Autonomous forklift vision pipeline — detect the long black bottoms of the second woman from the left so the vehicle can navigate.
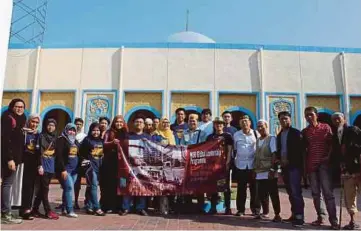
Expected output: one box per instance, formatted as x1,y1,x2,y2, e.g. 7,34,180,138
21,153,38,211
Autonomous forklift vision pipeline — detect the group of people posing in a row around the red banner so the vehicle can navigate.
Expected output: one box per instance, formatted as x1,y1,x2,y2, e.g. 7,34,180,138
1,99,361,230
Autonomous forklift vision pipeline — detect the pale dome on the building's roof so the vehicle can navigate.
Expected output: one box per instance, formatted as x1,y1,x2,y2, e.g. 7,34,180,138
168,31,216,43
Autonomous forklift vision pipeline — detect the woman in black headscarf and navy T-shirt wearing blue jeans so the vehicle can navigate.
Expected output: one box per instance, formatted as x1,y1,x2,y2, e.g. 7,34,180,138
80,122,105,216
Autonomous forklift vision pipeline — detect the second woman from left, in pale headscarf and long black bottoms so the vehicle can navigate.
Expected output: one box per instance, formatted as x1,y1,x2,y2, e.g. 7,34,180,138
20,114,40,220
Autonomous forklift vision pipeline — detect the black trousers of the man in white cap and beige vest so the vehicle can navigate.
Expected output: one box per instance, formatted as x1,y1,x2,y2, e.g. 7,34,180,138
255,178,281,215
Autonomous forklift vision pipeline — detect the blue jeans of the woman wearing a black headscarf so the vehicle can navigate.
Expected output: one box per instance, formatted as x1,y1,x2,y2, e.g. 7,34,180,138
85,168,100,210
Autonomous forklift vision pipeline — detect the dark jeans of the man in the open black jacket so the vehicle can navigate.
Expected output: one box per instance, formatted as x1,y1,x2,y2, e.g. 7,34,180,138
282,167,305,220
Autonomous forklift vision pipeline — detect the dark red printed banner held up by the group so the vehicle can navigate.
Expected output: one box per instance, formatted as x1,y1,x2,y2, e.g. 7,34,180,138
118,140,228,196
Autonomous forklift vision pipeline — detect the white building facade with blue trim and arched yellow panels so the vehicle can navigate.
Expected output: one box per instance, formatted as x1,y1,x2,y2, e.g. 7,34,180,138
2,43,361,133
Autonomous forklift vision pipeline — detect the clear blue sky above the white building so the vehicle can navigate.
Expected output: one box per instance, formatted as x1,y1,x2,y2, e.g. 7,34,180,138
8,0,361,48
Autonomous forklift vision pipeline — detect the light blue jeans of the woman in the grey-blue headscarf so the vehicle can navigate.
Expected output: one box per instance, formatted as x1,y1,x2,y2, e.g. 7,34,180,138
60,172,78,213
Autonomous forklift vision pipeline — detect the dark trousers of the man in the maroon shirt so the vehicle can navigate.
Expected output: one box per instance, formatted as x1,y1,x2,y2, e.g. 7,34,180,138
309,164,337,223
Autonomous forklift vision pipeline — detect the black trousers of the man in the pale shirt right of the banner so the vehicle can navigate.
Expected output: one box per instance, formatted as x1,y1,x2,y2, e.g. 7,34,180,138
234,168,257,213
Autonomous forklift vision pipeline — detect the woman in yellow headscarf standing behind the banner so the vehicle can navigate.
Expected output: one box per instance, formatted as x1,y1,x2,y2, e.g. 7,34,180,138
156,117,176,215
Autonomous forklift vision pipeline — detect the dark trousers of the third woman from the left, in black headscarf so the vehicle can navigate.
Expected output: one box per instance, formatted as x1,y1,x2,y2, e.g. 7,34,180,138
33,172,54,213
